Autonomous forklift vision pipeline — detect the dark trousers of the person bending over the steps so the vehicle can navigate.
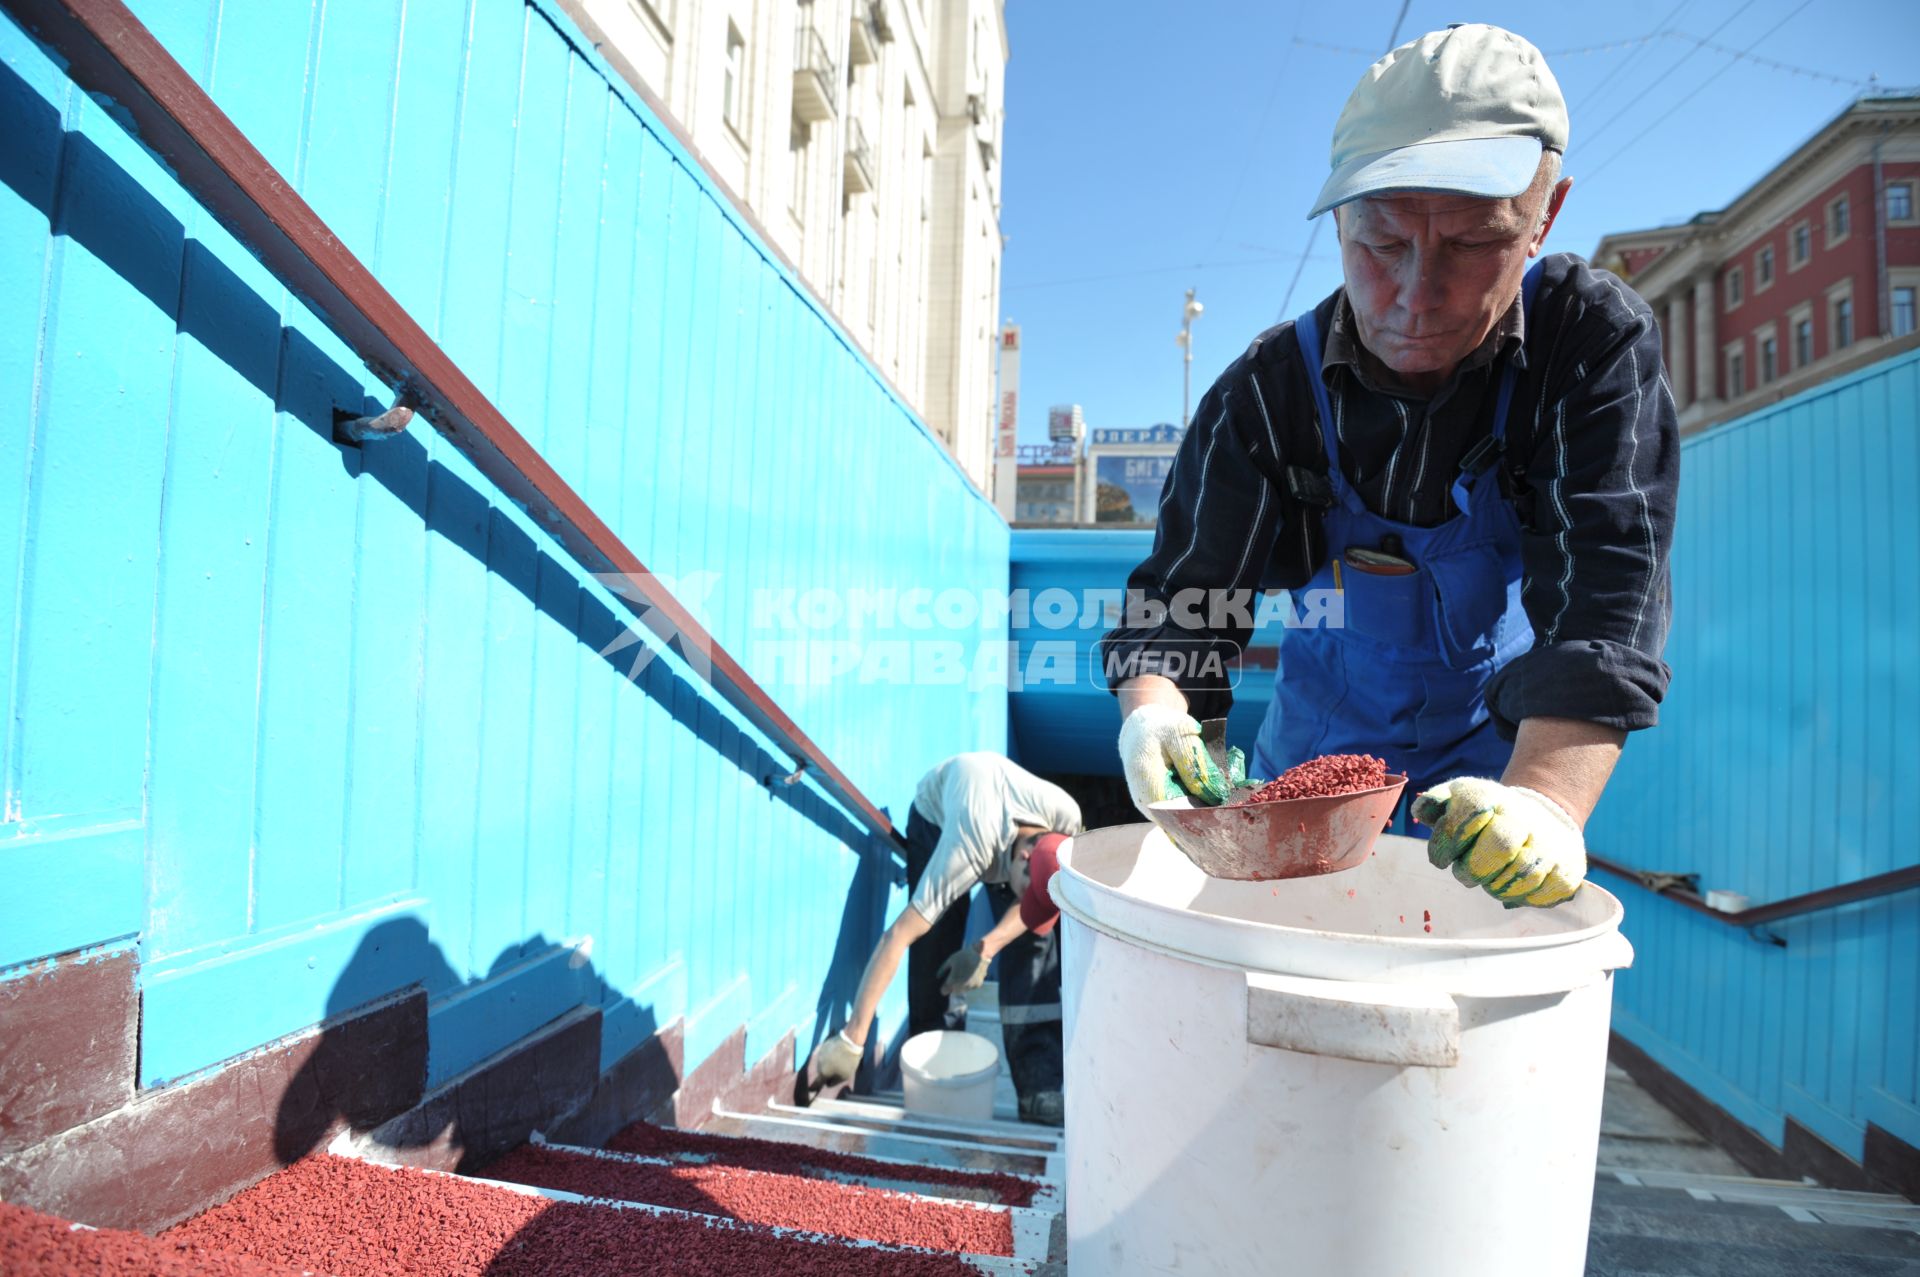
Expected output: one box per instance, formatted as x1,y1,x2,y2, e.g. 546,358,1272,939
906,808,1064,1095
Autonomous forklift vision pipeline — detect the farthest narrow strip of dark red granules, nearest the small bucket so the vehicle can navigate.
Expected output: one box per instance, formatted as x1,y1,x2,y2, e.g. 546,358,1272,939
607,1121,1062,1212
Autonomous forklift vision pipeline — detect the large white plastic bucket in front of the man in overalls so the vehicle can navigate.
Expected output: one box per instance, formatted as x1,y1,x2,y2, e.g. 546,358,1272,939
1050,824,1632,1277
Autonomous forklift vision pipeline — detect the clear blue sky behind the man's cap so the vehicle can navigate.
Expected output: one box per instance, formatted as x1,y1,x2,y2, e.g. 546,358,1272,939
1000,0,1920,442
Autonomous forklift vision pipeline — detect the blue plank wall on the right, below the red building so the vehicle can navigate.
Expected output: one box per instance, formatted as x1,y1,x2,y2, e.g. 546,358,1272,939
1590,345,1920,1160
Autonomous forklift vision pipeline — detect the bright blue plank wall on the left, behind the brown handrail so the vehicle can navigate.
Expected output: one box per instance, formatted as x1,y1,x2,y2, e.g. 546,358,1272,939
0,0,1008,1083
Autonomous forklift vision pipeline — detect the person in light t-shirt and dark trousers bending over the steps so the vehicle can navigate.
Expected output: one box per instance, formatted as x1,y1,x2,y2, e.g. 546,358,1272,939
808,753,1081,1125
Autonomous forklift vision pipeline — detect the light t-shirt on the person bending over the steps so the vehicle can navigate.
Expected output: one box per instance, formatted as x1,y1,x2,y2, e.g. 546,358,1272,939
912,753,1081,922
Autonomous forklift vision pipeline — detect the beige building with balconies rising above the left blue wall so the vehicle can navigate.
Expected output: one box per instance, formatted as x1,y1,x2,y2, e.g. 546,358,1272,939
563,0,1008,492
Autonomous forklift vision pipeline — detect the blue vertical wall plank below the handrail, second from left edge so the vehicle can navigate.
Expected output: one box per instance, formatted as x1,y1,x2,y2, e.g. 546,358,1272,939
15,98,186,820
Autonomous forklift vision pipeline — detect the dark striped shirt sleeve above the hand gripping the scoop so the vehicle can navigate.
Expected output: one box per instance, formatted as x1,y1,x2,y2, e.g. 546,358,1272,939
1098,351,1283,718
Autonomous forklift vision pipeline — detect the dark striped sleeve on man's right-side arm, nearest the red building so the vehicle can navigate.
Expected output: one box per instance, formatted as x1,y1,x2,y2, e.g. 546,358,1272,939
1486,271,1680,739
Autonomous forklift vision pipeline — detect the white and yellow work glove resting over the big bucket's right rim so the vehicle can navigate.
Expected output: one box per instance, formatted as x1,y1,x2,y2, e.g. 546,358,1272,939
1413,776,1586,908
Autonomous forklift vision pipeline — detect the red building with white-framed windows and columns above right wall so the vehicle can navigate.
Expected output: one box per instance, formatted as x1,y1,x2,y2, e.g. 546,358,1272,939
1594,92,1920,430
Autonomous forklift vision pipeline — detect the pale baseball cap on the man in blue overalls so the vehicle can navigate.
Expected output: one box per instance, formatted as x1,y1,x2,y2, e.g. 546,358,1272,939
1308,23,1567,217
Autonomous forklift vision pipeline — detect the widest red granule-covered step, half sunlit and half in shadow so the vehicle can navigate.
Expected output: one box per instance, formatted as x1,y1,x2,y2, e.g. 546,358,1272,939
163,1154,973,1277
